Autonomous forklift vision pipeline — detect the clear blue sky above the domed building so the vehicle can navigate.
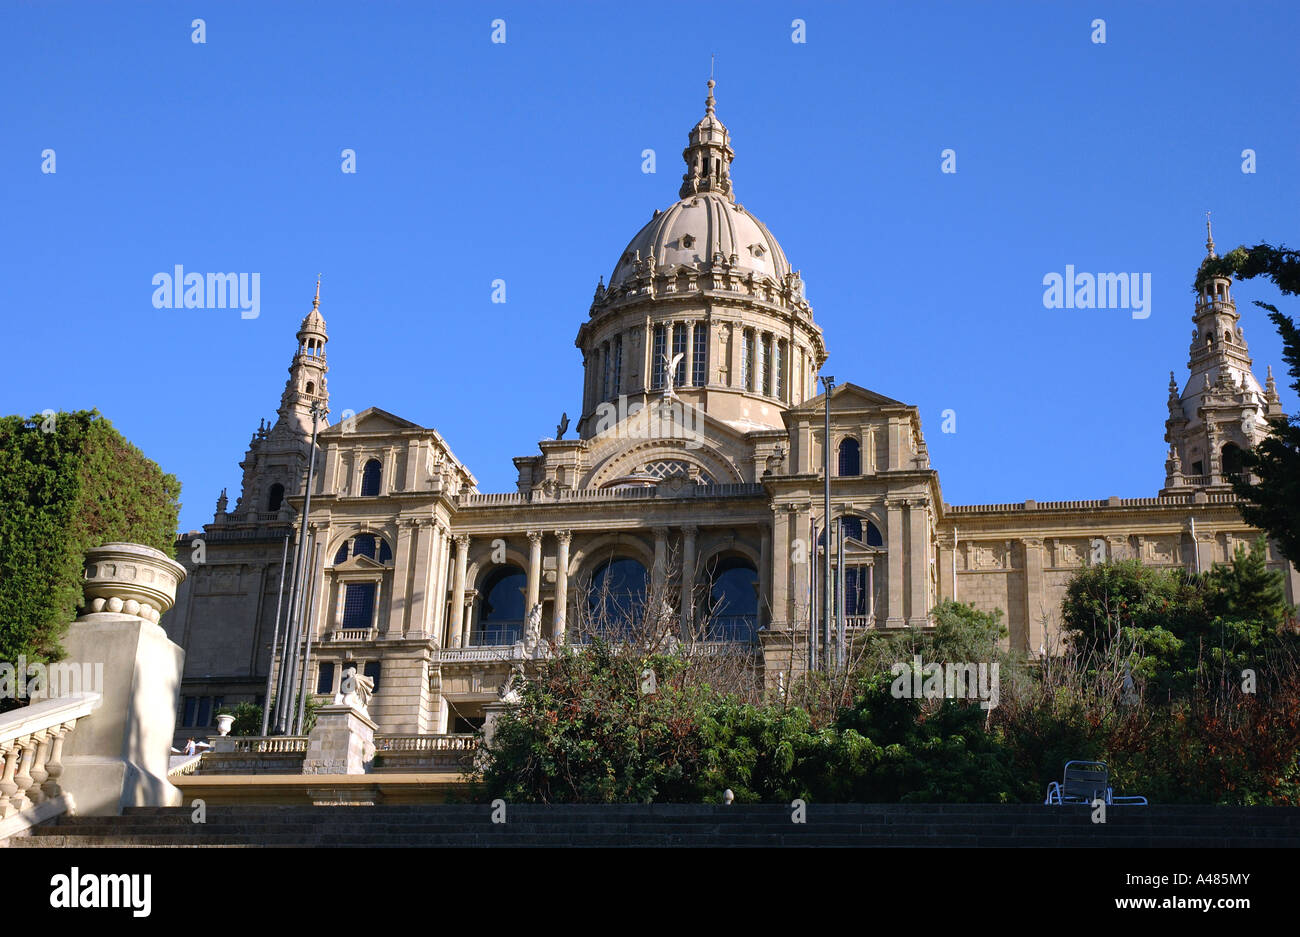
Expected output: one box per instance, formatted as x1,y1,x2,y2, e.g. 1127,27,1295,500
0,0,1300,530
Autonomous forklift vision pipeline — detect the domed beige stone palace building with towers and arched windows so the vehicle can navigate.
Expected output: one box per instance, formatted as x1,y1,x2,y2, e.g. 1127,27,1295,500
164,81,1300,737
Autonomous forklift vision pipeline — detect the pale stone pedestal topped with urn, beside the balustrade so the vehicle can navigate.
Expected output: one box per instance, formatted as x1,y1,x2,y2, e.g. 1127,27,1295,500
58,543,186,816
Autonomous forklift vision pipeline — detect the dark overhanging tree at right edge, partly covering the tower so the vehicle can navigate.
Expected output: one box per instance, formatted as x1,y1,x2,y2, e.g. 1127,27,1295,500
1195,244,1300,564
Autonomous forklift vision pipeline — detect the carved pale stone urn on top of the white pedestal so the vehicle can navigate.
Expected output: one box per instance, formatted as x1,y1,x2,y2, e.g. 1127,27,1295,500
82,543,186,625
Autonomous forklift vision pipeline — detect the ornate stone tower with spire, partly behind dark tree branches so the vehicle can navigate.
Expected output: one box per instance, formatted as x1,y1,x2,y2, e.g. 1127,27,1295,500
1161,216,1282,494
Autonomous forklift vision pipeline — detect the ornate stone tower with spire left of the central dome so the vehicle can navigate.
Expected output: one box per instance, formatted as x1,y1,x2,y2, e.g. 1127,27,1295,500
216,279,329,525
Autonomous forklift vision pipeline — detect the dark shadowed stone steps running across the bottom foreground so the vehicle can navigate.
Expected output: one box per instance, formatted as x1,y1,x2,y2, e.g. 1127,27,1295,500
8,804,1300,849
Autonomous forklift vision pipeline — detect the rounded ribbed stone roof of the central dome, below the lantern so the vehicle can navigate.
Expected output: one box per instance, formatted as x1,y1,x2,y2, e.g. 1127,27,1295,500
610,192,790,289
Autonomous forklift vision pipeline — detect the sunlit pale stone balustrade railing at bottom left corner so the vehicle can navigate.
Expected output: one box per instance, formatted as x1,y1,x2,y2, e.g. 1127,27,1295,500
0,693,101,840
